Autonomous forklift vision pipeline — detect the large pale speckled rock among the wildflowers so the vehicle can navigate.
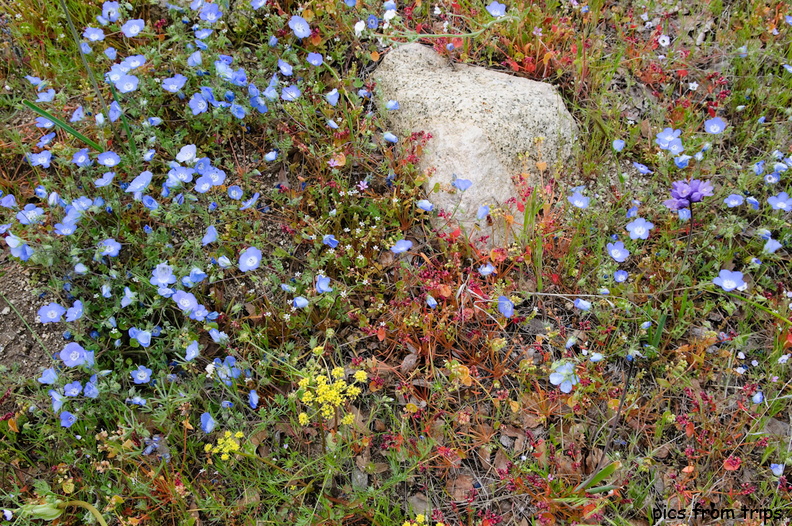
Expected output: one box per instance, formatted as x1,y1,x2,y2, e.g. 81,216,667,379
373,44,577,246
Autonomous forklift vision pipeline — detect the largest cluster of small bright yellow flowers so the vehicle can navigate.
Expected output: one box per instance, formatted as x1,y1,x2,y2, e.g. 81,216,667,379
297,367,368,426
